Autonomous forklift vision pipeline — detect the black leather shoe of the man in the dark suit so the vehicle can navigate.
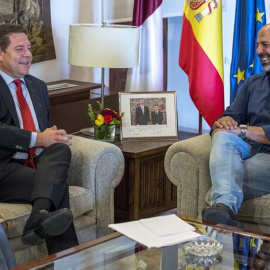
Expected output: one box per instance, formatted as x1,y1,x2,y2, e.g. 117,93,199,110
22,208,73,246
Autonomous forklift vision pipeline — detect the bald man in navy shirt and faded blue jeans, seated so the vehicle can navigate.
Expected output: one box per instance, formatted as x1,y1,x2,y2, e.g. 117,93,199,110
202,24,270,226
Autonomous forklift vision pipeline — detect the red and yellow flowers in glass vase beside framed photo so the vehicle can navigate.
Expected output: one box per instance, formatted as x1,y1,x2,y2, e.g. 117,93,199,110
88,101,124,141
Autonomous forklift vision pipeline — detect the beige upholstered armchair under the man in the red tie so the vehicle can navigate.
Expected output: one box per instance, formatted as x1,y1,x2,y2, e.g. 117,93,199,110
0,136,124,265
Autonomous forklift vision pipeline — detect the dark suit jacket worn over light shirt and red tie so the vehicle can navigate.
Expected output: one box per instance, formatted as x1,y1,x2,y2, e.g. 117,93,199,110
0,75,51,175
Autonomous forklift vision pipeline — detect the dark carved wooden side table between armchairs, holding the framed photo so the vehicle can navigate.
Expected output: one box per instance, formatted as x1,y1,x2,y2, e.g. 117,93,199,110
114,140,177,222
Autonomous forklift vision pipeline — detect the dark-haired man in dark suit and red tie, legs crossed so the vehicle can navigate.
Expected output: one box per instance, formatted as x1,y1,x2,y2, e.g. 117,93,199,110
0,24,78,254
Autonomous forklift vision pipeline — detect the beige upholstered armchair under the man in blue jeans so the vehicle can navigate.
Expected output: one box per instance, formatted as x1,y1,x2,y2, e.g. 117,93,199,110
165,134,270,233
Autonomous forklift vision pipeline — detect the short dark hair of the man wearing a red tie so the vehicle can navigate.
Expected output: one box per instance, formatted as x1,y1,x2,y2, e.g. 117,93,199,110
0,24,28,52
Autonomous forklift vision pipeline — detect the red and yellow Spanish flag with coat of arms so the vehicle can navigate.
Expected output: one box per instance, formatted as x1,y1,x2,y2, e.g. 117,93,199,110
179,0,224,126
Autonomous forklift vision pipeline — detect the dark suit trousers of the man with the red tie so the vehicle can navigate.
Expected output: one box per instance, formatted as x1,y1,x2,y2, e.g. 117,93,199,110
0,143,78,254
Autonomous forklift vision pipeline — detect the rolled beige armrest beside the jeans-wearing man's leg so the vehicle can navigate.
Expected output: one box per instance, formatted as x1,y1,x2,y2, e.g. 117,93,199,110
164,134,211,218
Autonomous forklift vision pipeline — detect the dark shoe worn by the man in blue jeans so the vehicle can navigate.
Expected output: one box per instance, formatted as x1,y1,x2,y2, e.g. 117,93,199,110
202,203,244,228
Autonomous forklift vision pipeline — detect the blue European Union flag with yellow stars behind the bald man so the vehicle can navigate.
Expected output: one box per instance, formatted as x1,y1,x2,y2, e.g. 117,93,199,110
230,0,266,103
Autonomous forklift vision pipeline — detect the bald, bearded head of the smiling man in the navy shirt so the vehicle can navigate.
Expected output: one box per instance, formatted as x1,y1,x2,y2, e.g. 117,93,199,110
256,24,270,71
